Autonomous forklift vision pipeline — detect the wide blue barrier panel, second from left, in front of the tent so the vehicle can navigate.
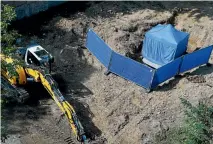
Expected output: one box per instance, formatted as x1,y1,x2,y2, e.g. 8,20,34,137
109,52,154,89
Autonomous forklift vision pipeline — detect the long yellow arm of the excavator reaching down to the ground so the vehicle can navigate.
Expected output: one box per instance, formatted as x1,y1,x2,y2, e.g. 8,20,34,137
25,68,87,144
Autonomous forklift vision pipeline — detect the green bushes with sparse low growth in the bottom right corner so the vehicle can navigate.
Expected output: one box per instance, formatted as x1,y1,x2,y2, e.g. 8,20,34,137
156,98,213,144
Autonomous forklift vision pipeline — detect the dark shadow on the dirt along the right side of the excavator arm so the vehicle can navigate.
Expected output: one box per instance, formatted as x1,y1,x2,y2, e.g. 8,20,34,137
53,75,102,139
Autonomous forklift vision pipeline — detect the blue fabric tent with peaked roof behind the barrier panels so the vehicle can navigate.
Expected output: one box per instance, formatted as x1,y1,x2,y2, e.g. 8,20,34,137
142,24,189,66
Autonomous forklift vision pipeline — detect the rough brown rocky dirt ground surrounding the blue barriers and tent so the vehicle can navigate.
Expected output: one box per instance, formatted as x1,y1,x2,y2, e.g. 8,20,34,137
2,2,213,144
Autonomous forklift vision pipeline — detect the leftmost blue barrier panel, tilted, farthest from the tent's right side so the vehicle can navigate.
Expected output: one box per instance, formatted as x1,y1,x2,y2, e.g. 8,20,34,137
86,29,112,68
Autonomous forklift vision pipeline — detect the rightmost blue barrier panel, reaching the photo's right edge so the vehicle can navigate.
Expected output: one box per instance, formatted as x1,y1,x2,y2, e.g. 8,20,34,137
179,46,213,73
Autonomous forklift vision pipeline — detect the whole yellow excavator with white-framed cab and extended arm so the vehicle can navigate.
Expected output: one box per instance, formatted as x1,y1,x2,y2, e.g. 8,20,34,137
0,44,87,144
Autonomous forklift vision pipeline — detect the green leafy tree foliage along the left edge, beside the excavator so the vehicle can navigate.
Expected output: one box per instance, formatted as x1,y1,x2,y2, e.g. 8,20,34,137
0,5,22,141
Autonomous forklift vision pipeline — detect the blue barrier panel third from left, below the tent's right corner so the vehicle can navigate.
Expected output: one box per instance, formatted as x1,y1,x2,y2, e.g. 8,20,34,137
152,57,182,88
